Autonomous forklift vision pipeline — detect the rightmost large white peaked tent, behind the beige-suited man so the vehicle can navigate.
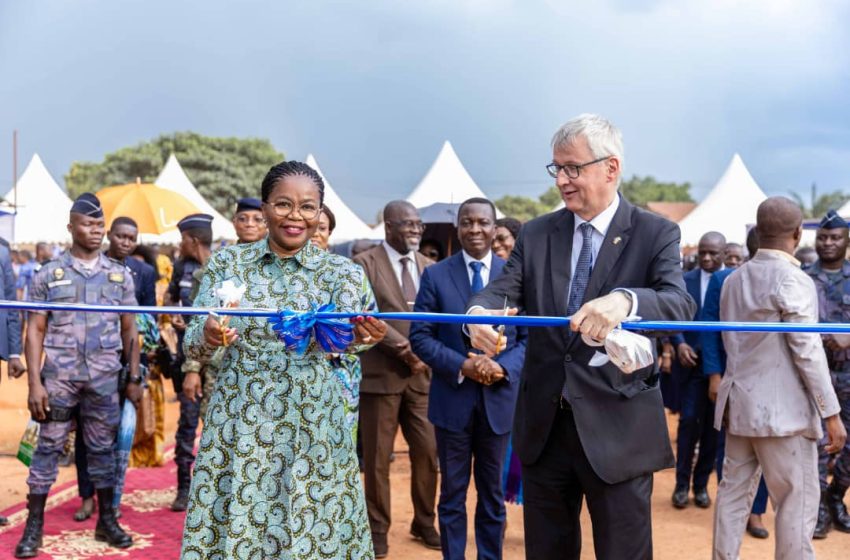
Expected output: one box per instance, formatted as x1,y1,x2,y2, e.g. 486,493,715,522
679,154,767,245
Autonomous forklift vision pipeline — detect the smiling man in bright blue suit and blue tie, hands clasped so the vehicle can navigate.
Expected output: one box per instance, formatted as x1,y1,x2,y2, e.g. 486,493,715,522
410,198,527,560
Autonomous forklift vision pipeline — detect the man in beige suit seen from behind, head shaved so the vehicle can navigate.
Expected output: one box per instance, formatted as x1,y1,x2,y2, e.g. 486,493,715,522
714,197,847,560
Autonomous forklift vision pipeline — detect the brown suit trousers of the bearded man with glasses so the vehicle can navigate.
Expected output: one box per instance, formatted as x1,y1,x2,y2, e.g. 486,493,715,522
360,387,437,533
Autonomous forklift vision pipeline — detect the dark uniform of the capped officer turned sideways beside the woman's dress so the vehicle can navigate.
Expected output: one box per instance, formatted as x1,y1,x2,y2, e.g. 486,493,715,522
168,259,202,469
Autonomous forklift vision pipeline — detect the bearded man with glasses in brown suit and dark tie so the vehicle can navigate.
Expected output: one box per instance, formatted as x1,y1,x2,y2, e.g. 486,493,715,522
354,200,440,558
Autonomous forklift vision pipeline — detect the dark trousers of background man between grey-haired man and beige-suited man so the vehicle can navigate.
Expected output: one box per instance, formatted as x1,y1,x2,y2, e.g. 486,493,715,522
676,370,717,490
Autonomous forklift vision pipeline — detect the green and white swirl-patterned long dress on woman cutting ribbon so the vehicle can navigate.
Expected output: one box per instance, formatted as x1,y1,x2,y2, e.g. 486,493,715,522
182,240,373,560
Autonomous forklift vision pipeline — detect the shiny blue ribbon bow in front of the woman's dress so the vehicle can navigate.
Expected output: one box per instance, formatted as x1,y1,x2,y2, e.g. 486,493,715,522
269,303,354,354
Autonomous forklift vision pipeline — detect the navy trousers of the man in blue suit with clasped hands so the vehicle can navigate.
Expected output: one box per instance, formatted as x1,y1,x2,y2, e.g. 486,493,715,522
435,390,511,560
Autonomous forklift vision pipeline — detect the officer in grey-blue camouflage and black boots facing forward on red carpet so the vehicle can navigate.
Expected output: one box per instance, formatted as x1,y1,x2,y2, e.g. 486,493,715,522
15,193,141,558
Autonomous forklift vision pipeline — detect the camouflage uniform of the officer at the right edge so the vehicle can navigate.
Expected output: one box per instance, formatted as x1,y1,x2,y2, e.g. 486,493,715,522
806,261,850,491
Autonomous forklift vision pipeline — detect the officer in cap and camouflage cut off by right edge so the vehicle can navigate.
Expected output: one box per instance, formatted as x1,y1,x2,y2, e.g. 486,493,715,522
806,210,850,539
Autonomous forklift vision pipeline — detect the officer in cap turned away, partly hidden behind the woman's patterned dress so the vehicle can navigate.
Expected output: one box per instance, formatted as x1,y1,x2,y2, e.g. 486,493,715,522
168,214,213,511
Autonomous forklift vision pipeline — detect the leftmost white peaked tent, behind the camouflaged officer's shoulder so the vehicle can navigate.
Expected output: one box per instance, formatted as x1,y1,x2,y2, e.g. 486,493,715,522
3,154,73,243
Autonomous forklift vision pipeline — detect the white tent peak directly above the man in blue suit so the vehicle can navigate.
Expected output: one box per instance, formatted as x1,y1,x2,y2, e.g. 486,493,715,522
407,140,502,218
